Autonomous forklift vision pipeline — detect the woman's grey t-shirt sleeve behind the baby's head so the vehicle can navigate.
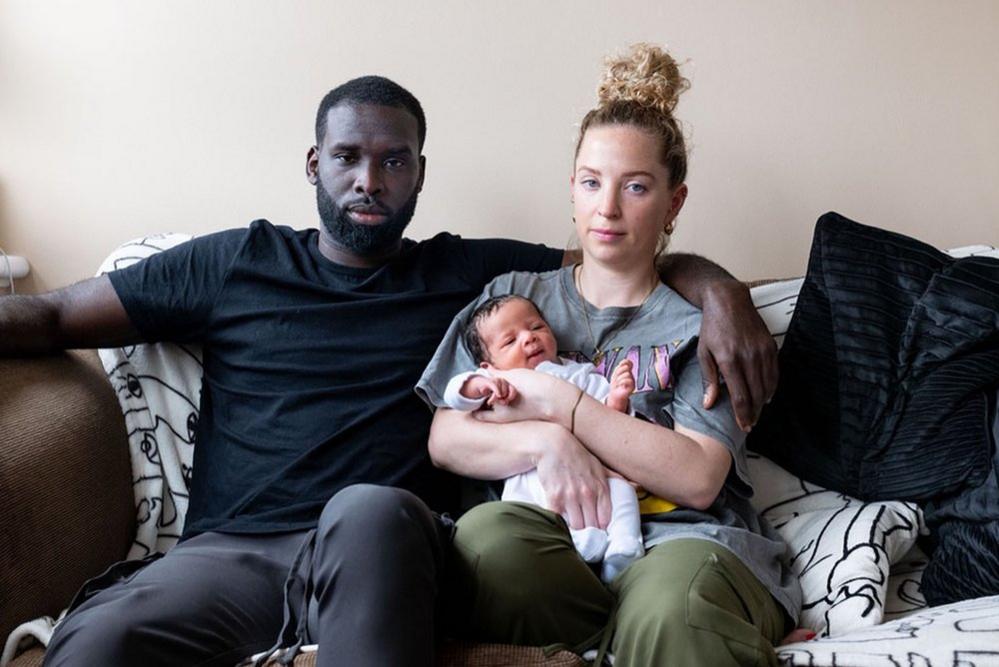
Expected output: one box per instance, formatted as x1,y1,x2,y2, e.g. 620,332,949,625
416,273,518,409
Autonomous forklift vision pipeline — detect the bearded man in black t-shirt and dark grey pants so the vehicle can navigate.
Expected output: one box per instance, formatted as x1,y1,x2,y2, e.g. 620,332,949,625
0,77,775,666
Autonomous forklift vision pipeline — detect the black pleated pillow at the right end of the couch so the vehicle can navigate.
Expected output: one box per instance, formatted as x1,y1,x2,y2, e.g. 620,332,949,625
748,213,999,602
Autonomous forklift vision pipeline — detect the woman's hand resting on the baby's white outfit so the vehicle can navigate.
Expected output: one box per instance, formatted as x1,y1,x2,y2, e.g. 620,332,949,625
537,424,611,530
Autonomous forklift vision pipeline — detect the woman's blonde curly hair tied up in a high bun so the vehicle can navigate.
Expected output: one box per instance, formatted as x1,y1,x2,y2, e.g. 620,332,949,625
576,43,690,187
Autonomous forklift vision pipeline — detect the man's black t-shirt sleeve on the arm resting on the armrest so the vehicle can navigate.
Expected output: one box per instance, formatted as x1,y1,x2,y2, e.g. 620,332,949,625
108,230,246,343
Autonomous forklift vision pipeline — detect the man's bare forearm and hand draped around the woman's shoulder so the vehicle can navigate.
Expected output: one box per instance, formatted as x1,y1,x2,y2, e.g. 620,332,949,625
658,253,778,431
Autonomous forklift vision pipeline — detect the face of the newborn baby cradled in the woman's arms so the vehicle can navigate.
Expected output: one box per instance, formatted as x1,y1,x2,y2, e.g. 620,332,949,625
479,299,558,370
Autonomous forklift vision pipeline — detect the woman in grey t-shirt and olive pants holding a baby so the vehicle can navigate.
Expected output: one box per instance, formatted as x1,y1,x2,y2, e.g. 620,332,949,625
420,45,800,666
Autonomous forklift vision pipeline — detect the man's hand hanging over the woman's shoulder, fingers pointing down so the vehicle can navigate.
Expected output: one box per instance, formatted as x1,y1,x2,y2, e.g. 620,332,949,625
697,280,778,433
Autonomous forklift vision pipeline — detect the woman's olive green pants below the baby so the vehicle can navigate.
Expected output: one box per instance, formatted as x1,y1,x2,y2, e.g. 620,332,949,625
446,502,785,667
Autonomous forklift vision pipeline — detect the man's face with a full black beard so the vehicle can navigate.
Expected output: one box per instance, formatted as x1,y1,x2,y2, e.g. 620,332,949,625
306,103,423,256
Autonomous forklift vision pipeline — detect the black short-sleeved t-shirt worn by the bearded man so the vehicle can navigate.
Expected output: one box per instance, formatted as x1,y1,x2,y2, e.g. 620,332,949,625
109,220,562,537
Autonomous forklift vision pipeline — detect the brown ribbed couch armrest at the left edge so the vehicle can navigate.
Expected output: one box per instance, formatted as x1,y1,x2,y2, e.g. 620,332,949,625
0,351,135,645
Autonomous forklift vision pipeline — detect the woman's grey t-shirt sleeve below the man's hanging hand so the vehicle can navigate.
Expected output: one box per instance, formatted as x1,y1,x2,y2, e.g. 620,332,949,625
665,355,752,497
